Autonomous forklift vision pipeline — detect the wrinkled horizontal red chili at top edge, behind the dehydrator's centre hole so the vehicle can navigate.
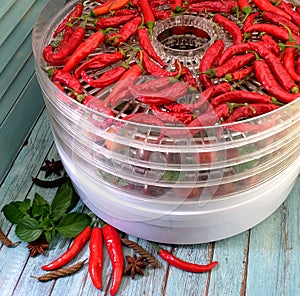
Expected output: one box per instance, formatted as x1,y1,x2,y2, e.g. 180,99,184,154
189,1,238,13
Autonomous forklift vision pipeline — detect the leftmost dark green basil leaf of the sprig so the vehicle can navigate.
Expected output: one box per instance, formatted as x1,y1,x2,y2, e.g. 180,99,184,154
2,199,30,224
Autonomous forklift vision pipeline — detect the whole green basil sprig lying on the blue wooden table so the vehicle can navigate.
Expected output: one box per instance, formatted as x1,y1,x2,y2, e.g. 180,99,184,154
2,180,91,243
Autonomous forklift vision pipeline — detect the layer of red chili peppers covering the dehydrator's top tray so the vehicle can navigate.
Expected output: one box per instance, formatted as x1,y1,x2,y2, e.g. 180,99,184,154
43,0,300,134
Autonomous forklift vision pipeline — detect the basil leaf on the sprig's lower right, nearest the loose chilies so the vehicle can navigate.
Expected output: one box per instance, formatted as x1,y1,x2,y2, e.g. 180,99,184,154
56,212,91,238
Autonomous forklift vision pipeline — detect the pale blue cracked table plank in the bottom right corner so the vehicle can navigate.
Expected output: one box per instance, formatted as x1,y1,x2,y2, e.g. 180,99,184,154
246,176,300,296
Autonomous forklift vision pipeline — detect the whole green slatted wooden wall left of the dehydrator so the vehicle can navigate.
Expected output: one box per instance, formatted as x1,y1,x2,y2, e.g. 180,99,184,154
0,0,50,184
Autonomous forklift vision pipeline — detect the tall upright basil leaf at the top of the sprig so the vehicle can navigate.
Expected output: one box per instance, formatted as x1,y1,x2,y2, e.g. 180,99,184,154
51,181,73,221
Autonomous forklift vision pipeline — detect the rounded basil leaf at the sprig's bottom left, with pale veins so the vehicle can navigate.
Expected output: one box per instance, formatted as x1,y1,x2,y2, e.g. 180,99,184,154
16,218,43,243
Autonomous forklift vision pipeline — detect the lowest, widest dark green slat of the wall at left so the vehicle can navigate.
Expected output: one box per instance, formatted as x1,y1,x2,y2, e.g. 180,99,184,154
0,76,44,180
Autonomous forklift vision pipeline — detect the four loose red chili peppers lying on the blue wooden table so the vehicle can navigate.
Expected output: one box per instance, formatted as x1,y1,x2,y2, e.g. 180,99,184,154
42,221,218,295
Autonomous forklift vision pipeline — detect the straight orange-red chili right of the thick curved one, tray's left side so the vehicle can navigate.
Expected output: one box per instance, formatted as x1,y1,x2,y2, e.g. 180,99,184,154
62,31,105,72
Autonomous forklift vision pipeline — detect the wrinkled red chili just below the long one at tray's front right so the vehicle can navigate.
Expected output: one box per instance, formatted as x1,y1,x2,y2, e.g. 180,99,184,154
226,103,279,123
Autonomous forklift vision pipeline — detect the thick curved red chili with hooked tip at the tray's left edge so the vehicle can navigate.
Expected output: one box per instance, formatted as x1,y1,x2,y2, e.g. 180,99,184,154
43,27,85,66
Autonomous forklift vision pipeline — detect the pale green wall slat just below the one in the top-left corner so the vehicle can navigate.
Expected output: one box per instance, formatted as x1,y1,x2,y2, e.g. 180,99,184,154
0,0,36,46
